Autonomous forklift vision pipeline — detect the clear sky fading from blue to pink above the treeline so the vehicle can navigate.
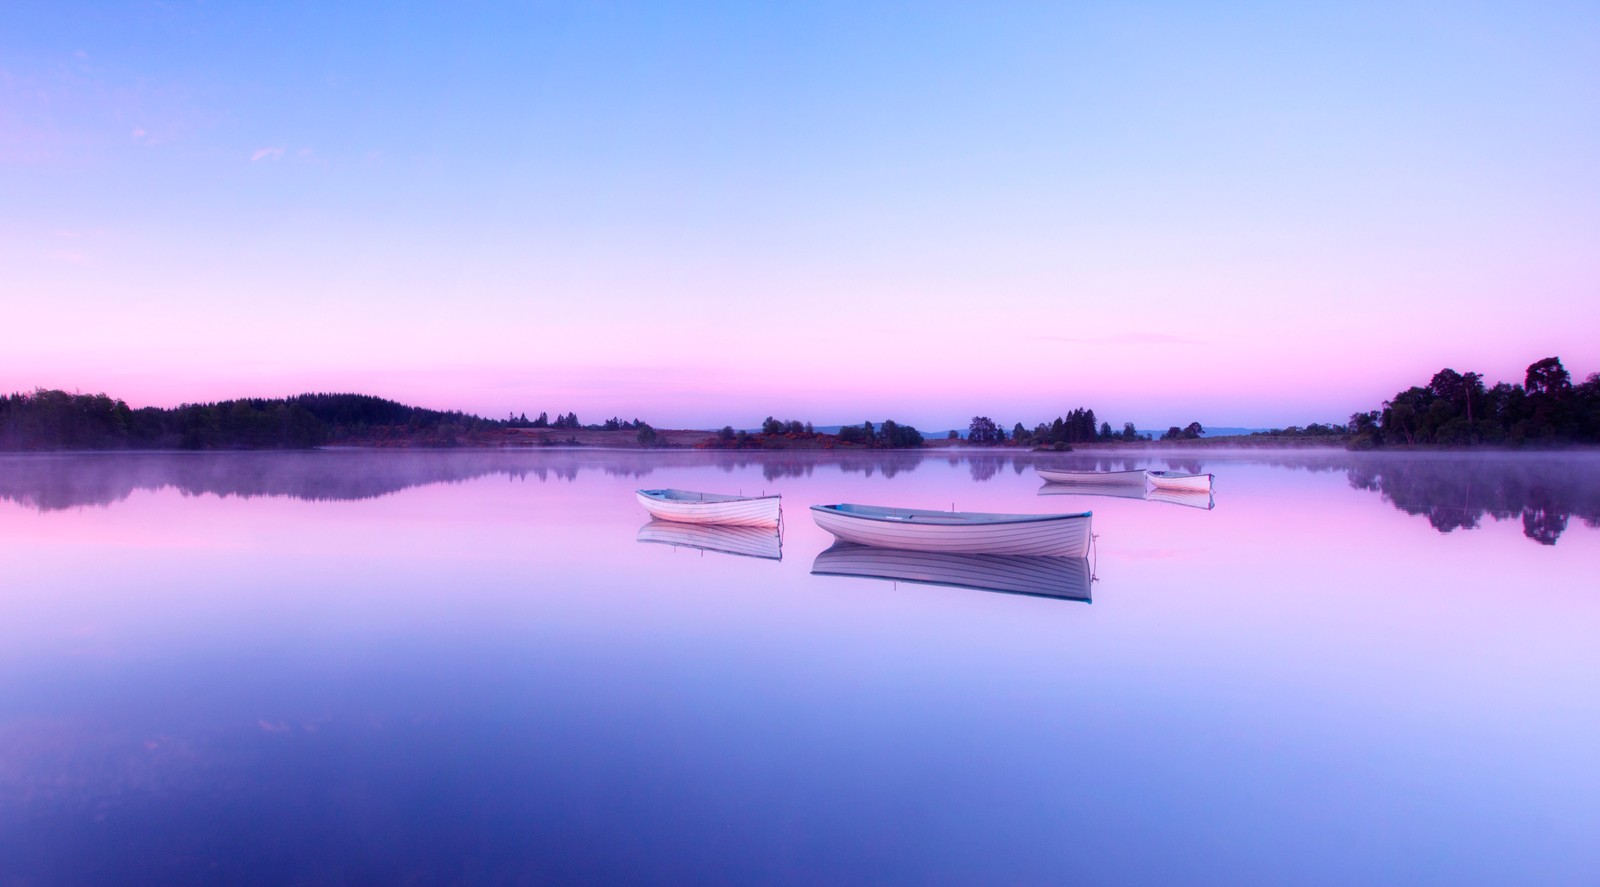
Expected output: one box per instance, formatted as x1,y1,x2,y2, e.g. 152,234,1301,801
0,2,1600,427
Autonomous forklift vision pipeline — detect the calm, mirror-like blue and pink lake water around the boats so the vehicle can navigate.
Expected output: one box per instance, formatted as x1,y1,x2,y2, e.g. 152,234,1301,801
0,450,1600,885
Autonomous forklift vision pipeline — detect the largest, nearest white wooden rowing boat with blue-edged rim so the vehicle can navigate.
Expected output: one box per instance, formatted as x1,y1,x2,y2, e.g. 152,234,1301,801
811,504,1091,557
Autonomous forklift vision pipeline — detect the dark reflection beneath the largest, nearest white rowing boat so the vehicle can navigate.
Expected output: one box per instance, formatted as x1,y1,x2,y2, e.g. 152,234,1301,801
811,543,1093,604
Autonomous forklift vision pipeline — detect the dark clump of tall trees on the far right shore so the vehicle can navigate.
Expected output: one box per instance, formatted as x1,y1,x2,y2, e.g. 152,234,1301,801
1350,357,1600,450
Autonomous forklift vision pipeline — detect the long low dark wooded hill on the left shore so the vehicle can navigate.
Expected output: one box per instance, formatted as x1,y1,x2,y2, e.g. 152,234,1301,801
0,389,506,450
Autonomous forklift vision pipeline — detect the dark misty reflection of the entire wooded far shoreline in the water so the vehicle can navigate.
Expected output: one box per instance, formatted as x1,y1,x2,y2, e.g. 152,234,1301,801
0,448,1600,544
